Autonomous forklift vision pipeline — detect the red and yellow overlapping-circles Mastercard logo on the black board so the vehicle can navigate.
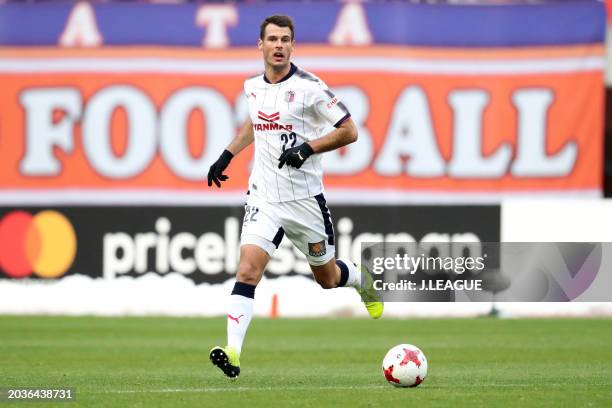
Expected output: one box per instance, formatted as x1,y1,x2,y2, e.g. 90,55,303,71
0,210,77,278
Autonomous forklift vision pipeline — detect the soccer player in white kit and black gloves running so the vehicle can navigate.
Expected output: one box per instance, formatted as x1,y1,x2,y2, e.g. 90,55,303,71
208,15,383,378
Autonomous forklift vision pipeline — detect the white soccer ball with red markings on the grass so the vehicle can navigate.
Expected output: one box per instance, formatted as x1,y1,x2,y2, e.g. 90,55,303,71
382,344,427,387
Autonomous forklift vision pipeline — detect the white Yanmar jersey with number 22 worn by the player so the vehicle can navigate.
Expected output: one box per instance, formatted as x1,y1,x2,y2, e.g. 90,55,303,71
244,64,350,202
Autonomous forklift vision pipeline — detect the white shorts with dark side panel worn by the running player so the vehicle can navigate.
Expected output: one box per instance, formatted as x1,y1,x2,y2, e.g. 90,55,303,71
240,193,336,266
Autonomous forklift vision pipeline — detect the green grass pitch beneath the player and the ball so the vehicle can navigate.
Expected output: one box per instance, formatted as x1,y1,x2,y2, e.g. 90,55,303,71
0,316,612,408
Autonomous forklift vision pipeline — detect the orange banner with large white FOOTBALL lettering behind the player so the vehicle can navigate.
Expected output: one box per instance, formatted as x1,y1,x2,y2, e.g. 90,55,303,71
0,46,604,204
